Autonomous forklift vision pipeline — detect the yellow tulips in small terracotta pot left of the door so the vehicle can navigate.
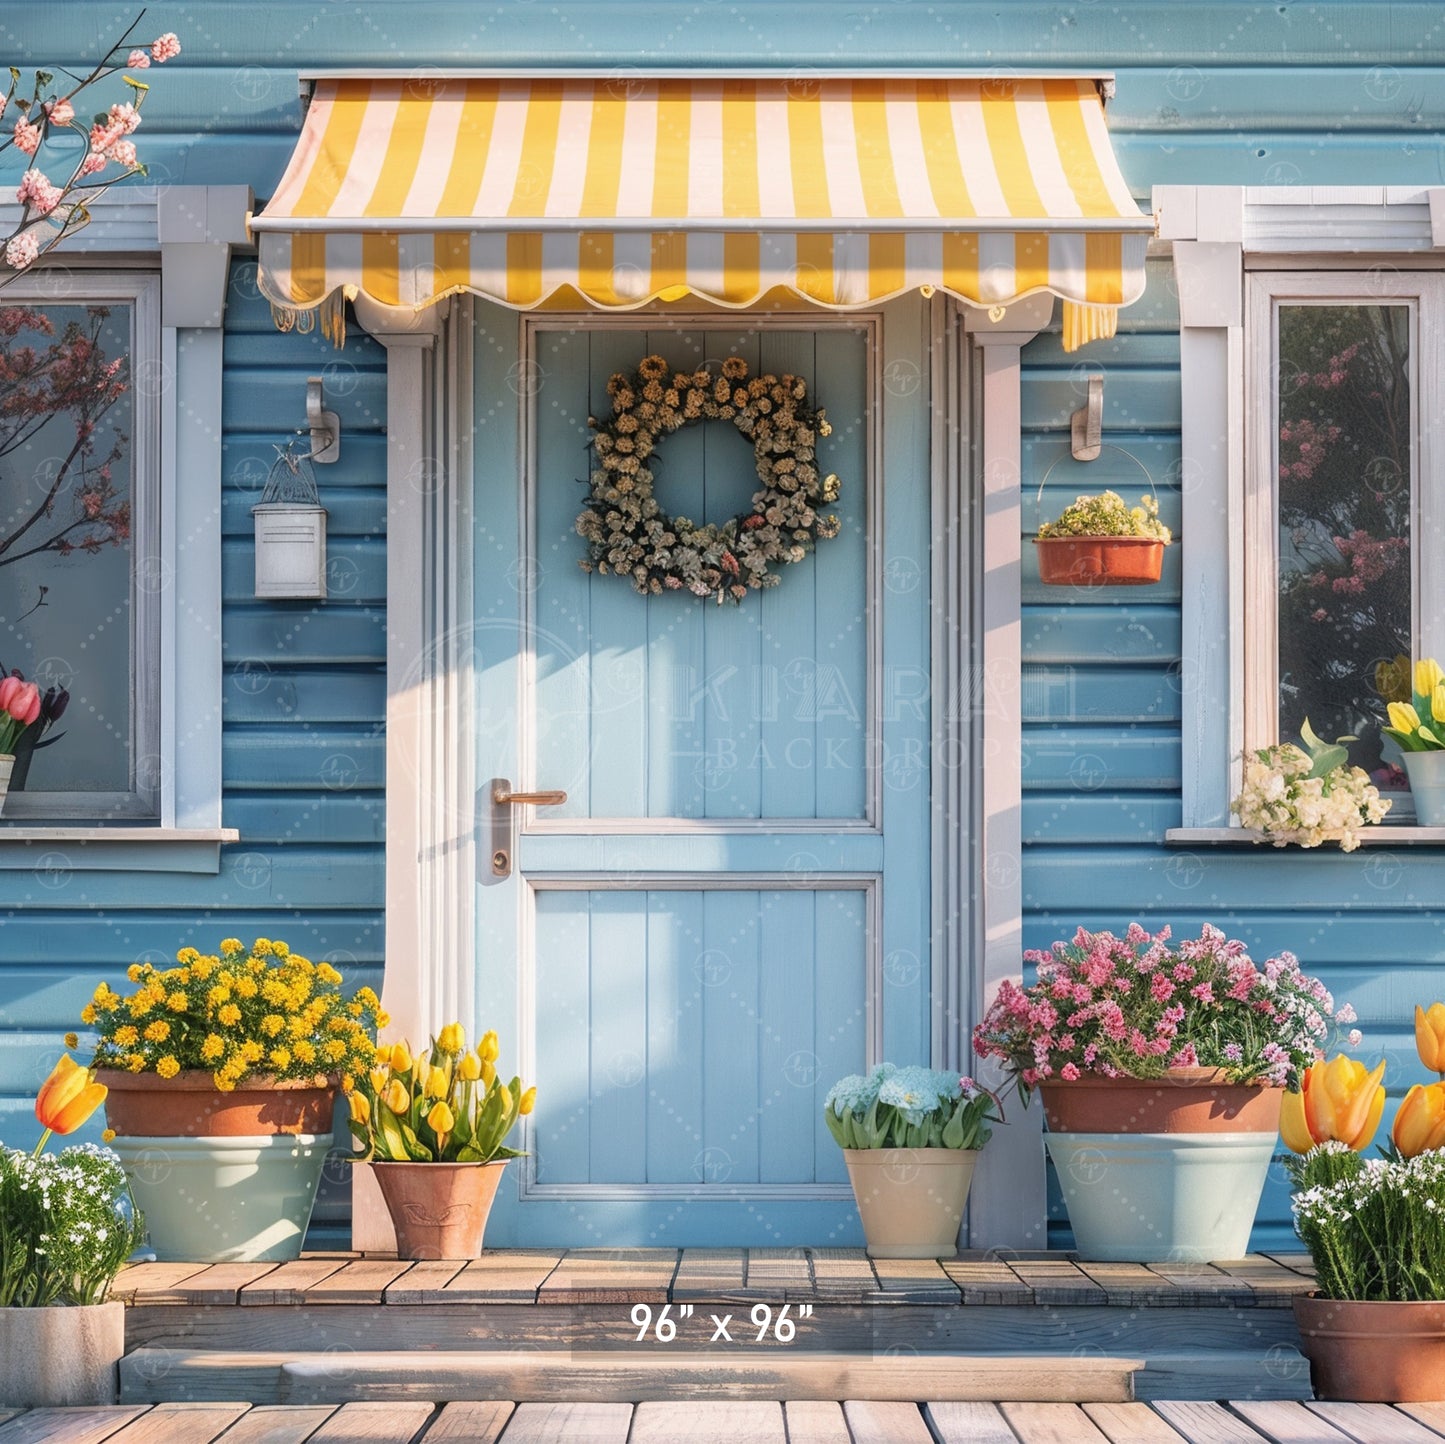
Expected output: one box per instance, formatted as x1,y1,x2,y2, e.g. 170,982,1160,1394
350,1023,536,1259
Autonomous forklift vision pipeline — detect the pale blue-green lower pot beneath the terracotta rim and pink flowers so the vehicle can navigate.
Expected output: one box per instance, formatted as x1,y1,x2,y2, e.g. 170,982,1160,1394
1043,1133,1277,1263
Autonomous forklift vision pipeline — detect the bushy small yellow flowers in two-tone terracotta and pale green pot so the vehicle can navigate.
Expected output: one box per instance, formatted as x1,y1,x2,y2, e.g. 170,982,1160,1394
81,938,386,1263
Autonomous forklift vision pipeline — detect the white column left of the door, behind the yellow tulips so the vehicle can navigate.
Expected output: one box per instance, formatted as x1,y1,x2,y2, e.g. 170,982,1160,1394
351,298,475,1253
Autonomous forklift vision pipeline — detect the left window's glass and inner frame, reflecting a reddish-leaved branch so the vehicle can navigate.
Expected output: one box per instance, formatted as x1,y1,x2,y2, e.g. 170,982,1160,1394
0,270,162,822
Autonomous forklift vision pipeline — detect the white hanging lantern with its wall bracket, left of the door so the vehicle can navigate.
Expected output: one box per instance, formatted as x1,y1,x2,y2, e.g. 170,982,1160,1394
251,376,341,598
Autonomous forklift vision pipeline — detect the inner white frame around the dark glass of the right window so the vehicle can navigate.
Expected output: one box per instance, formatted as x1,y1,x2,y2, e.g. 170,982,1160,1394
1231,267,1445,827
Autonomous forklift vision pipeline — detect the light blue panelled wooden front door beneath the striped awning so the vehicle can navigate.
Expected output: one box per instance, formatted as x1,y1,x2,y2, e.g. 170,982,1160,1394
474,296,931,1246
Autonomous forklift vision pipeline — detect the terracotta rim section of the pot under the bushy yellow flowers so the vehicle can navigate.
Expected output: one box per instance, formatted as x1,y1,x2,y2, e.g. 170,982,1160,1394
95,1068,337,1138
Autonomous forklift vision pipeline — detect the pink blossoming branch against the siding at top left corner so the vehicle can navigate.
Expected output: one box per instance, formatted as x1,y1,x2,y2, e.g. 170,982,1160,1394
0,12,181,278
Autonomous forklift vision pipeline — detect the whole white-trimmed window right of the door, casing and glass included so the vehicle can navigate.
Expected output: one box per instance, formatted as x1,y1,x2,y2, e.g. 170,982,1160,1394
1153,185,1445,846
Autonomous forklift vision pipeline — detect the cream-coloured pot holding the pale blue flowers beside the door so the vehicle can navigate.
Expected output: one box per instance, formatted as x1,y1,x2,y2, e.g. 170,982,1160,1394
842,1148,978,1259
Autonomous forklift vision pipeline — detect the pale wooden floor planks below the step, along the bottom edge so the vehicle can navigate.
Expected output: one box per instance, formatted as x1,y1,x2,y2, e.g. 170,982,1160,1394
0,1401,1445,1444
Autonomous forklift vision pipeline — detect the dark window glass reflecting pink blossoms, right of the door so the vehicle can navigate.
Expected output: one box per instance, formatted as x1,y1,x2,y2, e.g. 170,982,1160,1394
1277,302,1418,785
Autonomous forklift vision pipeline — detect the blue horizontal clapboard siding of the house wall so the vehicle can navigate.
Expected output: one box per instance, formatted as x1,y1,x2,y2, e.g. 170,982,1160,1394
0,0,1445,1243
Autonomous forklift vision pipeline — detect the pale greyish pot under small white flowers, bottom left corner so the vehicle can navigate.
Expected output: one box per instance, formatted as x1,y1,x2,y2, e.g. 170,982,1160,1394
0,1302,126,1409
